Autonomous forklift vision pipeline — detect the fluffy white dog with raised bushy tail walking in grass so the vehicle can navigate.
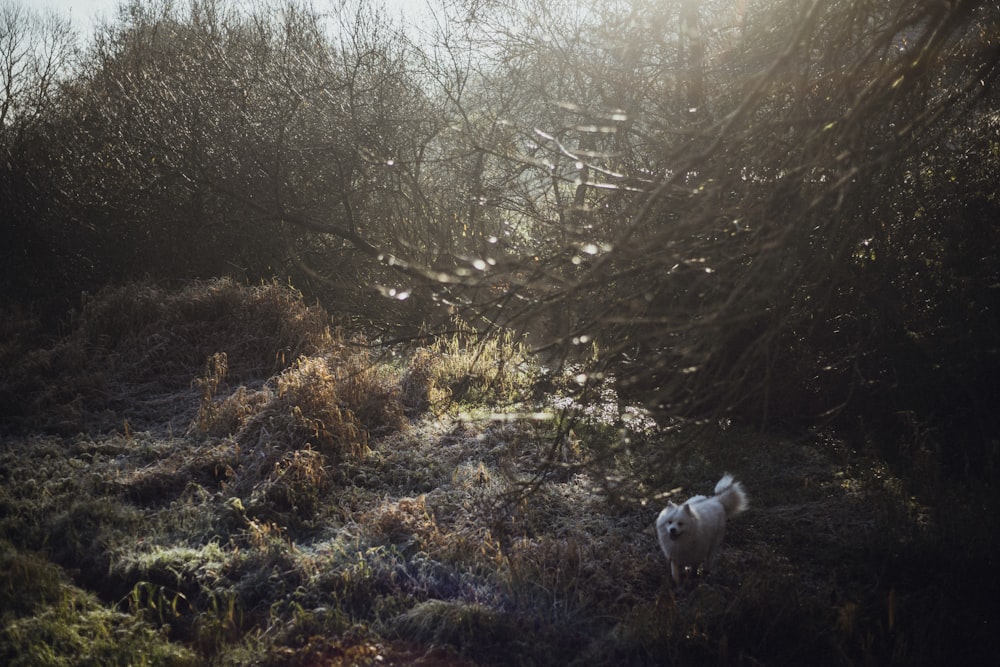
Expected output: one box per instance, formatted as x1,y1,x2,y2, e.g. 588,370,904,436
656,473,748,584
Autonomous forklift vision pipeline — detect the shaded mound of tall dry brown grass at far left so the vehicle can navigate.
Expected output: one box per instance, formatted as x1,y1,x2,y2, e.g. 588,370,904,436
0,279,332,433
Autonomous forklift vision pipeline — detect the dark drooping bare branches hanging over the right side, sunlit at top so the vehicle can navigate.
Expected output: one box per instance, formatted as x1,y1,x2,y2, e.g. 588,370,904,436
532,2,998,444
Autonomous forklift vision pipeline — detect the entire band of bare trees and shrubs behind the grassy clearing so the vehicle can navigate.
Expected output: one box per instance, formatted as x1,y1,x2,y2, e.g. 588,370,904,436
0,0,1000,460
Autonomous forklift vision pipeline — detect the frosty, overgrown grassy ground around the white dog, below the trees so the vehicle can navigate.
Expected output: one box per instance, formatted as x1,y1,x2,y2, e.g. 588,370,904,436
0,281,998,665
